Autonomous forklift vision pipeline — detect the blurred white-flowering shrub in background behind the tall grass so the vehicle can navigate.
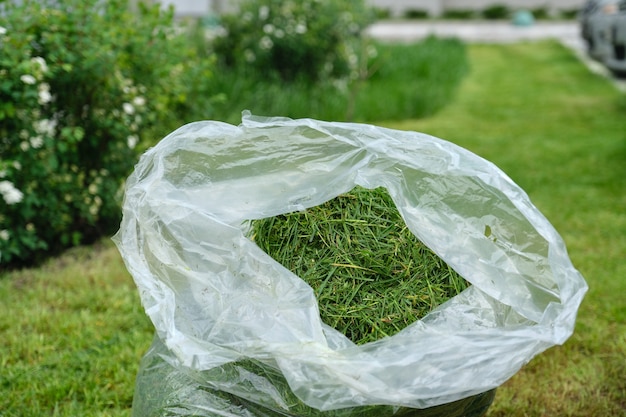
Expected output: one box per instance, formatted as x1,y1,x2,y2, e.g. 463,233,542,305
214,0,374,82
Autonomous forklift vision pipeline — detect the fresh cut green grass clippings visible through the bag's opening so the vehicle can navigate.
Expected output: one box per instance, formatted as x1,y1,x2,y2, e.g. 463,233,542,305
251,187,468,344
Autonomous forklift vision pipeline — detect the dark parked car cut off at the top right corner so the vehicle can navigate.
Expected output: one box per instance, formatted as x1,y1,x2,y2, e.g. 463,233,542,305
579,0,626,74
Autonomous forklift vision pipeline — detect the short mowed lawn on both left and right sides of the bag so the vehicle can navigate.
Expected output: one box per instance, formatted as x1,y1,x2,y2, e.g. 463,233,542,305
0,42,626,417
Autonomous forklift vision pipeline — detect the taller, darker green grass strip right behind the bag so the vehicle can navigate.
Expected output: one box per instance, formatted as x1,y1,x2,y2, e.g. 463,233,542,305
205,37,467,124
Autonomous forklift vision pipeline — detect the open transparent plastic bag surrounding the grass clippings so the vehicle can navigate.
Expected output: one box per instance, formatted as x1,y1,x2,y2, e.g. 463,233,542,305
114,113,587,416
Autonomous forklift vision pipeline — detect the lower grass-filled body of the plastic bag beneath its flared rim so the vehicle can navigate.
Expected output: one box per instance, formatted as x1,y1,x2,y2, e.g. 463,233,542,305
133,337,496,417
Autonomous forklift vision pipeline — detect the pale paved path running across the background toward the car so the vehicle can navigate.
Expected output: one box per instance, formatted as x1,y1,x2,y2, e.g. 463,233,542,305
367,20,626,91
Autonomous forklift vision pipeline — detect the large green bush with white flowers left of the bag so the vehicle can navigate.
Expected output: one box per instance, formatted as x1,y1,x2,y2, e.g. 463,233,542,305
0,0,217,266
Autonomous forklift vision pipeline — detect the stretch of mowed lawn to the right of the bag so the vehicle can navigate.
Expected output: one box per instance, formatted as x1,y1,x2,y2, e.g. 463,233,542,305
386,42,626,417
